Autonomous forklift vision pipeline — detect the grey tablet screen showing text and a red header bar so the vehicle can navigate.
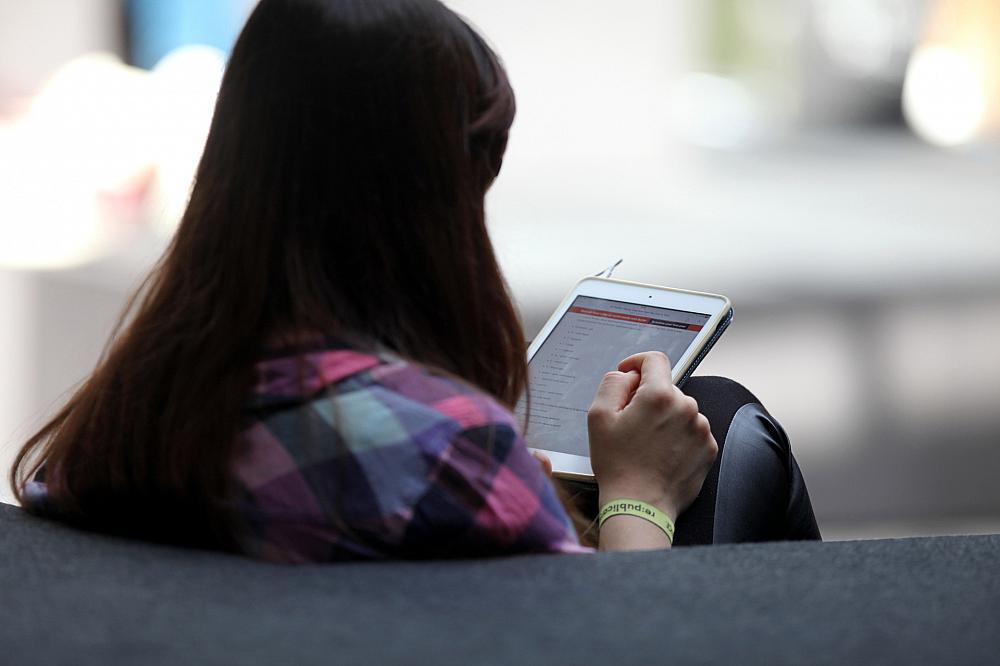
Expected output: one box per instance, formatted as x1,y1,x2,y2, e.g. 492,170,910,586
517,296,710,456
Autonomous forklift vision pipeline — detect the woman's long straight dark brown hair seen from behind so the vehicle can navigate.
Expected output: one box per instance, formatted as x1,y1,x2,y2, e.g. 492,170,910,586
10,0,527,547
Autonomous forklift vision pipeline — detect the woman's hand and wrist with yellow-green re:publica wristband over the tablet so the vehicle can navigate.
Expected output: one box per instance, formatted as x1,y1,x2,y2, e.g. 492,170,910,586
587,352,719,548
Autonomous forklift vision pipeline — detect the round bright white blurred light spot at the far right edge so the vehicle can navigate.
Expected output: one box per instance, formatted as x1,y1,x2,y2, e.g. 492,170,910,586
903,46,987,146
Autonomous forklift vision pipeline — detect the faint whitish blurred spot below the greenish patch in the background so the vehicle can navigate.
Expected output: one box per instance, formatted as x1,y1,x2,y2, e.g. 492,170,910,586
670,73,759,150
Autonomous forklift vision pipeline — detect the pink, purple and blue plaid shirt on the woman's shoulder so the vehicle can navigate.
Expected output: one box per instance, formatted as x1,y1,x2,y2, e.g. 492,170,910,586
235,340,589,562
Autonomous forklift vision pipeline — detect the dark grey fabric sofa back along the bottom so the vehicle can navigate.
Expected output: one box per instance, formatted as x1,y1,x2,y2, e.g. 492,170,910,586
0,505,1000,664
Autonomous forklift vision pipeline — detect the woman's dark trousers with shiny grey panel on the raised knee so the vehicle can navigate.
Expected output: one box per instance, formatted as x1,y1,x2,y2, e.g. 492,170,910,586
564,377,820,546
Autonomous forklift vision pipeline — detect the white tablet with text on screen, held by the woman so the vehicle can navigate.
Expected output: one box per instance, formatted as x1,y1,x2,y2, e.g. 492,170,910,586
517,277,733,482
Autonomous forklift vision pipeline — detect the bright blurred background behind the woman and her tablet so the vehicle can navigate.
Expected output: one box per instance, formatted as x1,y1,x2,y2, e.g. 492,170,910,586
0,0,1000,539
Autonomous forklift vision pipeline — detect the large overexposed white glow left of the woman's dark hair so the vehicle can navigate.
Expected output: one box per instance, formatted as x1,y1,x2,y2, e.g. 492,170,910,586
0,46,225,269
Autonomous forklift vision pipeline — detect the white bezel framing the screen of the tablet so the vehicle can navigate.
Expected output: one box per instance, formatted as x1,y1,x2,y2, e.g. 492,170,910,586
528,277,732,483
